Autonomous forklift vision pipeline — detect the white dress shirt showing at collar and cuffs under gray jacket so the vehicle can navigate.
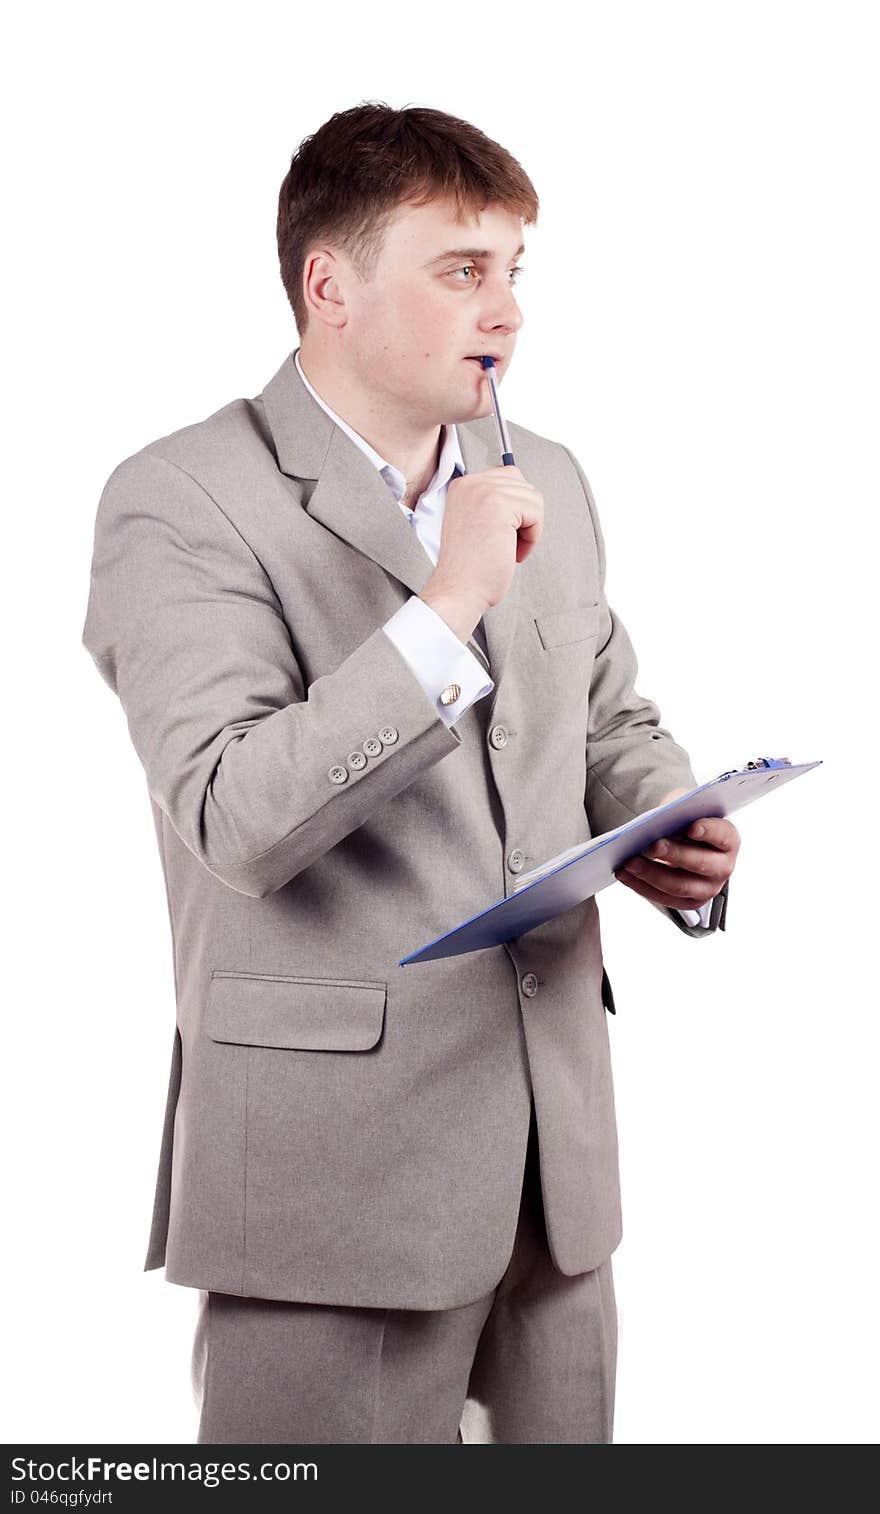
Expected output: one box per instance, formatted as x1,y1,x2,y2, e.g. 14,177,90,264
294,348,712,925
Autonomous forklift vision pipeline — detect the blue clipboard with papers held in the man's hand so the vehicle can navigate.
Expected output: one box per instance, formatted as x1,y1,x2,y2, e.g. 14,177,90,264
400,757,821,967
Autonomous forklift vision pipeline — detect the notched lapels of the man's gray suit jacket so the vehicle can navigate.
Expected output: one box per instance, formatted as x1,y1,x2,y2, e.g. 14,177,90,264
261,353,520,704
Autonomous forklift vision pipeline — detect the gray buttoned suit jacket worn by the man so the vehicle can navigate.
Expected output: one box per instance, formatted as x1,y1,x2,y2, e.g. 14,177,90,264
83,353,727,1310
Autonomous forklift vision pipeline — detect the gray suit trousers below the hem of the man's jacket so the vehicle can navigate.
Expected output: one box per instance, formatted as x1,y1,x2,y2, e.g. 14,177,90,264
192,1105,618,1446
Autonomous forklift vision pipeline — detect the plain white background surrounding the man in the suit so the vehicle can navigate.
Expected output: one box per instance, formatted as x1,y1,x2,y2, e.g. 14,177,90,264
2,0,880,1444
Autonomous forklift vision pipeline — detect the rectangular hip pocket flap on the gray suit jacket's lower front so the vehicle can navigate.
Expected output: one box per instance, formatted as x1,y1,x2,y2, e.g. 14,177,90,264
206,970,388,1051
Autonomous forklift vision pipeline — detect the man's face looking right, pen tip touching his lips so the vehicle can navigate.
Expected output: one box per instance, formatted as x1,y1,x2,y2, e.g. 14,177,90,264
309,201,524,428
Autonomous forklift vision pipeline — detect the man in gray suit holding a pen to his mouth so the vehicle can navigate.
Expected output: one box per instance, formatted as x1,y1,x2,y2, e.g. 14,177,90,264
83,104,739,1443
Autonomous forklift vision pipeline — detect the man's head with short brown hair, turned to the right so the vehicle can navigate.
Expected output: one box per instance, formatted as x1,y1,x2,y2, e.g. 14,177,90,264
277,103,538,431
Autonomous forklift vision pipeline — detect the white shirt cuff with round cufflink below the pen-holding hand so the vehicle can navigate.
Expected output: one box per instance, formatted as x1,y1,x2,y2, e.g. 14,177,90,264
382,593,495,725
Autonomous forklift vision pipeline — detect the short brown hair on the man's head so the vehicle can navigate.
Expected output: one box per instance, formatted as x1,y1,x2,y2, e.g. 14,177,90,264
277,100,538,338
